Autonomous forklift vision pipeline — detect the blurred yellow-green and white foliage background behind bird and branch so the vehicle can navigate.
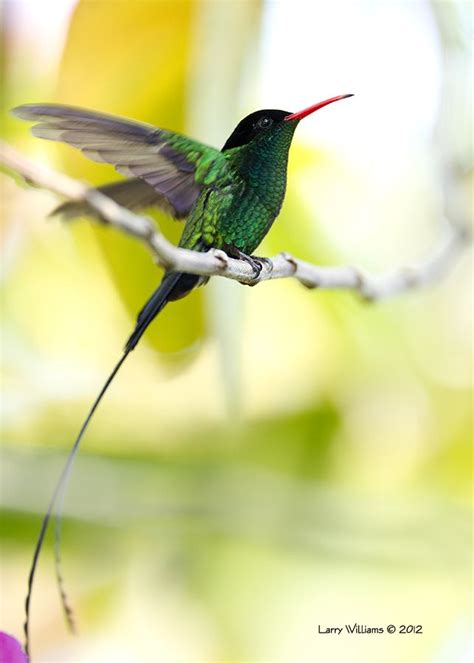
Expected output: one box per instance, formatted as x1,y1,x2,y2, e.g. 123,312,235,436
1,0,472,663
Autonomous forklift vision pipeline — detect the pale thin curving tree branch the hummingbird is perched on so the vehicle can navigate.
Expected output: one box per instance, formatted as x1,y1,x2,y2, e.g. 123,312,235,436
0,143,469,301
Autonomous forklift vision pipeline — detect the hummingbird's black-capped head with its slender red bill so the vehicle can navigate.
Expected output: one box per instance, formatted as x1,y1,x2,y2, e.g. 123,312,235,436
222,94,353,151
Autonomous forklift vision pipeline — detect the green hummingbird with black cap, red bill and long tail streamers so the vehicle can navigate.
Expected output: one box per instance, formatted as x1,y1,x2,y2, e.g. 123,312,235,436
12,94,353,655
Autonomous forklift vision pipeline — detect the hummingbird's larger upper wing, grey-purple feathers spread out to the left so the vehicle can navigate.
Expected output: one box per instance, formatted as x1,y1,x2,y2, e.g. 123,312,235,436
13,104,225,218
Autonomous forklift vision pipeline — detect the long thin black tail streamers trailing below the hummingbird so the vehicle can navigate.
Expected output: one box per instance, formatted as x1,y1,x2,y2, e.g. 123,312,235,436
24,350,130,661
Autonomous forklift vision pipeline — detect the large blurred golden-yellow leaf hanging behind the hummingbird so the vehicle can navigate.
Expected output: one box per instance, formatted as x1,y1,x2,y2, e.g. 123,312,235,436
54,0,204,358
